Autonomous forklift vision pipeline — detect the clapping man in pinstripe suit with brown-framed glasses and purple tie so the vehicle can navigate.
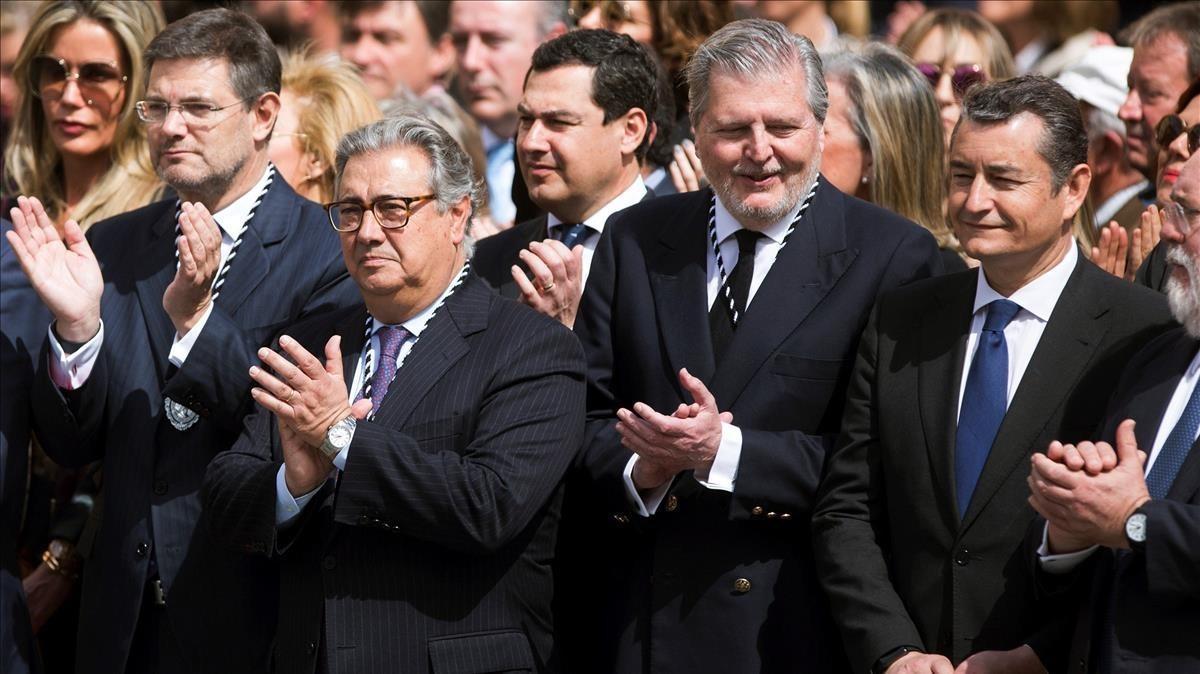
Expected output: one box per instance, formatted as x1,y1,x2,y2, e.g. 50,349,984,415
205,118,584,673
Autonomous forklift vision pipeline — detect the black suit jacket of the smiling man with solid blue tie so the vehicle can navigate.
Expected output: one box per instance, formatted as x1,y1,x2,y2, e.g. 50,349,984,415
812,257,1170,672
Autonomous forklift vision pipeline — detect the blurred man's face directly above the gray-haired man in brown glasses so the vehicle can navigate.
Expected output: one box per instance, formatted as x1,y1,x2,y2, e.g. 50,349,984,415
342,1,454,98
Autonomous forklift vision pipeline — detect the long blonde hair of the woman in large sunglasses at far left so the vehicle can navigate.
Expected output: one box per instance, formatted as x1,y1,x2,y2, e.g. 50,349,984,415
5,0,166,228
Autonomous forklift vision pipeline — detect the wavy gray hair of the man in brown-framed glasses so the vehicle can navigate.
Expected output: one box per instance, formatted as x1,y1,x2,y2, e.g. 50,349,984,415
335,115,484,255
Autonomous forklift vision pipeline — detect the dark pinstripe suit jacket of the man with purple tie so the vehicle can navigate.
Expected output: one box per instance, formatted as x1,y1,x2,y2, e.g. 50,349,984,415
205,276,584,674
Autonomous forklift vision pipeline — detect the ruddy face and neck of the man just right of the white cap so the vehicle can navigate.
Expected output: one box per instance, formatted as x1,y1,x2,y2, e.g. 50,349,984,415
1117,34,1188,180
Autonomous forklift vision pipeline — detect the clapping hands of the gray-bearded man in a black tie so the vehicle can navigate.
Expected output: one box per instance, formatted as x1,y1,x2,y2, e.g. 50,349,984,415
617,368,733,489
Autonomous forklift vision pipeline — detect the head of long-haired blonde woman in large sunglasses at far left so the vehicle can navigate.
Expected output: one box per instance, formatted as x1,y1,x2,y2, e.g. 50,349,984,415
2,0,166,228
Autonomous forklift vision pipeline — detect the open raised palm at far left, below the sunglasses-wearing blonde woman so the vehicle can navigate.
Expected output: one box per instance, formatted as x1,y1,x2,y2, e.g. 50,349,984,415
7,197,104,342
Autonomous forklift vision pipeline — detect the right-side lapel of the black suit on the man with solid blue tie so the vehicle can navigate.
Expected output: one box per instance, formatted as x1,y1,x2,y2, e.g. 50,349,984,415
962,258,1109,529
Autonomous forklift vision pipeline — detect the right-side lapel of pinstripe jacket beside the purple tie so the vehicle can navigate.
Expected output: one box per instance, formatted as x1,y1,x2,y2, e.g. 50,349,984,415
376,275,492,428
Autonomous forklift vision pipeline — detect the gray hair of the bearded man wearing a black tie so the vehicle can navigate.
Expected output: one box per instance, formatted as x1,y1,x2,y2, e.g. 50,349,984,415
684,19,829,126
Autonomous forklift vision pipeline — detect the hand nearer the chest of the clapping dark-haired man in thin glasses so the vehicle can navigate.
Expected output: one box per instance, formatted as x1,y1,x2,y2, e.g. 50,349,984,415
162,201,221,337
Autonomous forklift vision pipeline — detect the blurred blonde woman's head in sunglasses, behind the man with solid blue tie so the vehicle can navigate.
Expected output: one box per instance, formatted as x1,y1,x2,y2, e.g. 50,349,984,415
896,8,1016,148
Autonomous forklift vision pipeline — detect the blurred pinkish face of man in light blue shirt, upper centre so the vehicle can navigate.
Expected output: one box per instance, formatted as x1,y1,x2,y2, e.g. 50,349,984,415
450,1,548,137
